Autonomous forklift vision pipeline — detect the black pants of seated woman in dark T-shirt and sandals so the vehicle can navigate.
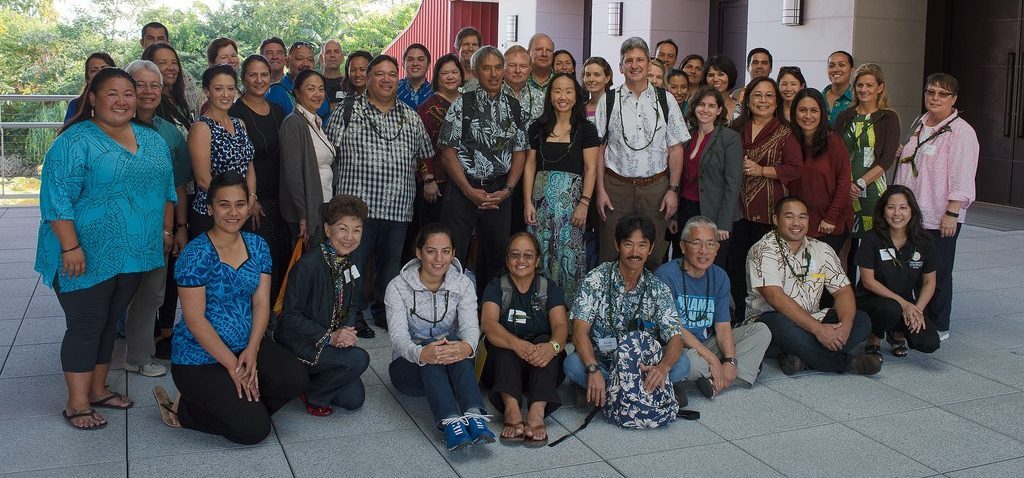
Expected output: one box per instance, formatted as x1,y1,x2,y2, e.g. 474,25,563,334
483,337,565,417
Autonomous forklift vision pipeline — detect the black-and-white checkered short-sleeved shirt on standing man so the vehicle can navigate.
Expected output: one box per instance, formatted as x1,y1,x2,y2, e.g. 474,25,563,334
327,95,434,222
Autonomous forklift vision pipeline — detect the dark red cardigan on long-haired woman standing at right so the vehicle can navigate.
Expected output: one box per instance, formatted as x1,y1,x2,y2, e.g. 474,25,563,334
788,133,853,237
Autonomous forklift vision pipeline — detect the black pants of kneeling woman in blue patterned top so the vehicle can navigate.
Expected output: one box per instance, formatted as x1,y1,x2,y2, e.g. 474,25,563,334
171,339,308,445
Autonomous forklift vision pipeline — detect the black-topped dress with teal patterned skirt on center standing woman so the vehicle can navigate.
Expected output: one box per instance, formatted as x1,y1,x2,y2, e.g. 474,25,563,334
527,122,600,303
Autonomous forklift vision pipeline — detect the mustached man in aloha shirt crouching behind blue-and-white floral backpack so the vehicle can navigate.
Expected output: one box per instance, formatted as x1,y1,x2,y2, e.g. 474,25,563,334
564,214,690,428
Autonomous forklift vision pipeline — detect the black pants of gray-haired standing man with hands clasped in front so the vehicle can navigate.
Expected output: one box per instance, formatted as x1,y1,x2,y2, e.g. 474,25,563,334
441,181,512,297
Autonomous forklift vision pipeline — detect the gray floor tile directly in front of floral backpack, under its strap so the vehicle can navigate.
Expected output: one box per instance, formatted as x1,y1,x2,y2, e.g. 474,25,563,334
553,407,725,460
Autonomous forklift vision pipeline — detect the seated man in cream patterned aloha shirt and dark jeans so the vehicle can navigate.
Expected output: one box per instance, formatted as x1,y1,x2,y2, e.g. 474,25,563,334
743,195,882,375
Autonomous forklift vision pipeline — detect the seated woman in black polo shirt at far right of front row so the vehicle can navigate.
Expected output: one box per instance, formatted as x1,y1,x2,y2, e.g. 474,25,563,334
857,185,939,358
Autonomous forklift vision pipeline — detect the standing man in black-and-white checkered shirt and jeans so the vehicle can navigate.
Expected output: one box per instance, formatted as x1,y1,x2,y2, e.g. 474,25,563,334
326,54,434,338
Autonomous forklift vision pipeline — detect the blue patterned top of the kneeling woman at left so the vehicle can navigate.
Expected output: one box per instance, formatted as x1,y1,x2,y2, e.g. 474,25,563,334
171,231,270,365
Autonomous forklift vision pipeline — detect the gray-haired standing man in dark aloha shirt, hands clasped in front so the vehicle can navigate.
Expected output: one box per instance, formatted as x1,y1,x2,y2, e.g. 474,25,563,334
437,45,528,295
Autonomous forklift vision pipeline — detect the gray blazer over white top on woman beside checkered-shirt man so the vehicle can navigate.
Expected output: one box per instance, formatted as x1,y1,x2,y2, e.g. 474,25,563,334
279,110,338,245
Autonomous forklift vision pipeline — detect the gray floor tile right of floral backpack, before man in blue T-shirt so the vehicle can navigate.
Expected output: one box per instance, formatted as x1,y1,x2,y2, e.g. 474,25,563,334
679,384,833,440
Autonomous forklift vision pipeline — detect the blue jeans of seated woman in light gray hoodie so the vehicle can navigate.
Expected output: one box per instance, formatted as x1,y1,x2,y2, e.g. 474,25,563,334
388,336,485,424
